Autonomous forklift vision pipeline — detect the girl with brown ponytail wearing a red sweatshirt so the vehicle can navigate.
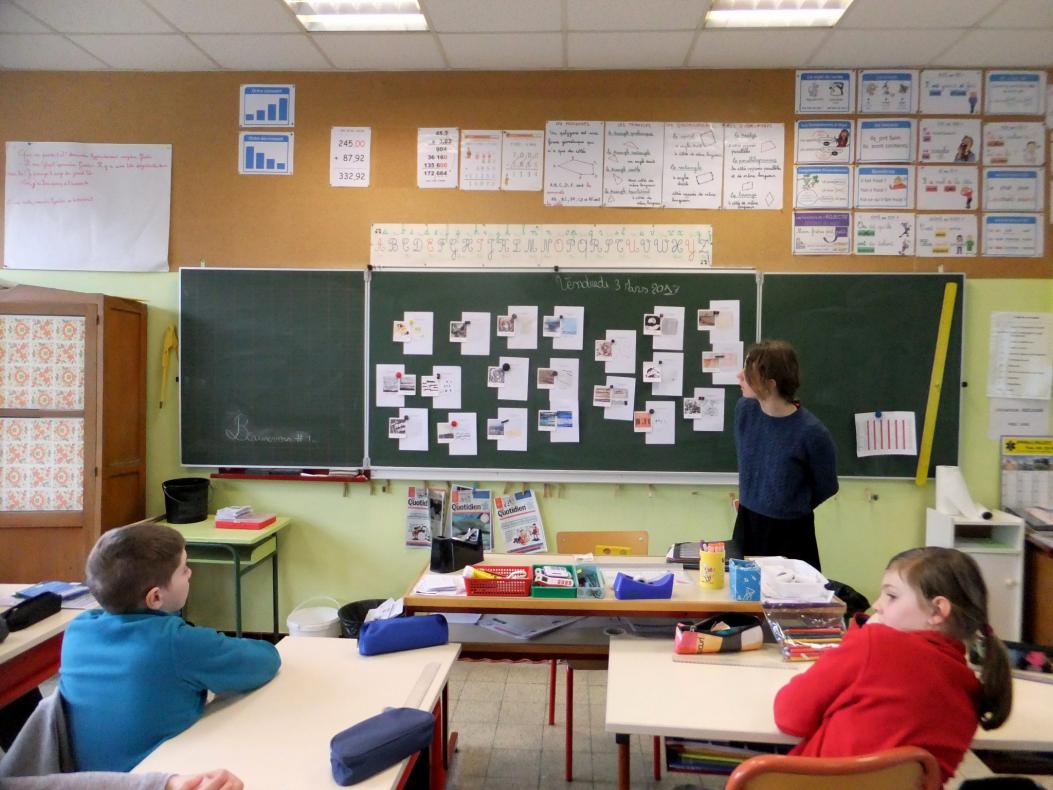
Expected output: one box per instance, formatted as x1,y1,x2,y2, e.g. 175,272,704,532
775,547,1012,781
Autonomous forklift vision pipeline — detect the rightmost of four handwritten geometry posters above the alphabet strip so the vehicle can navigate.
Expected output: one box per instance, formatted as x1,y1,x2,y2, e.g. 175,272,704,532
723,123,786,210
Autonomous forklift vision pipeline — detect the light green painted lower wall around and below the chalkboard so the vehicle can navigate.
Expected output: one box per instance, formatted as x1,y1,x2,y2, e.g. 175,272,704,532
3,271,1053,630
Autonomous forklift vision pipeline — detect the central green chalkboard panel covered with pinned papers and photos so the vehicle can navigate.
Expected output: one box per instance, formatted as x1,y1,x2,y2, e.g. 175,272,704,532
369,270,757,479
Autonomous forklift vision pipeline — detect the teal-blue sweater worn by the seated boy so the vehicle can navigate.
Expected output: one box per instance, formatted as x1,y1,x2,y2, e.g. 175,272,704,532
59,609,281,771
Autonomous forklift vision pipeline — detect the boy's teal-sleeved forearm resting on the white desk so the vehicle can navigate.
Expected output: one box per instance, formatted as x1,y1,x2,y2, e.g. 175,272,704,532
173,623,281,693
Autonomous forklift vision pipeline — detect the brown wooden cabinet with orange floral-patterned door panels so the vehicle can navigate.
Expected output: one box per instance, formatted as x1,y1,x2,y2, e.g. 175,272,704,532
0,285,146,581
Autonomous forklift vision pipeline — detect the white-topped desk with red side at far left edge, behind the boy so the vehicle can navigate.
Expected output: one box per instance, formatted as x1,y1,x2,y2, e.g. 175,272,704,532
0,584,81,708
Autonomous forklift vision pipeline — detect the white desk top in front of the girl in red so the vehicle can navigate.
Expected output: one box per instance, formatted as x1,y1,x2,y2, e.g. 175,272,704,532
607,638,1053,751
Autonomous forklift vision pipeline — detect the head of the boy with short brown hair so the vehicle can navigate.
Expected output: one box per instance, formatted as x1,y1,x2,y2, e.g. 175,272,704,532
85,522,186,614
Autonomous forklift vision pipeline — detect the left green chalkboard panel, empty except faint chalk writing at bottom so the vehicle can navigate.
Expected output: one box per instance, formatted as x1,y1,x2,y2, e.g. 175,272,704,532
185,269,365,469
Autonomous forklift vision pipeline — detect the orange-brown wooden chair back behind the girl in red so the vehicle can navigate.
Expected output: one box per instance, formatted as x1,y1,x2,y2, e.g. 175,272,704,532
724,746,943,790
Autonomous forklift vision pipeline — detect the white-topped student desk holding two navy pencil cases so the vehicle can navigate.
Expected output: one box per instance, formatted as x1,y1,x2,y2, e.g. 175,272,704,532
135,637,459,790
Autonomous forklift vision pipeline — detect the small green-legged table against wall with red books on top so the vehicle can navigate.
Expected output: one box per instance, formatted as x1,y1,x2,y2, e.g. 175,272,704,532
154,516,290,636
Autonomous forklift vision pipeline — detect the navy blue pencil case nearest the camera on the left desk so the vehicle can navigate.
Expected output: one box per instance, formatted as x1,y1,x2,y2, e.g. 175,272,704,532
330,707,435,787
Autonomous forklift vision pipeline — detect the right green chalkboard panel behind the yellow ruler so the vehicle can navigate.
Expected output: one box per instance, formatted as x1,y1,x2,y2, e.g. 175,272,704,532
761,274,965,477
